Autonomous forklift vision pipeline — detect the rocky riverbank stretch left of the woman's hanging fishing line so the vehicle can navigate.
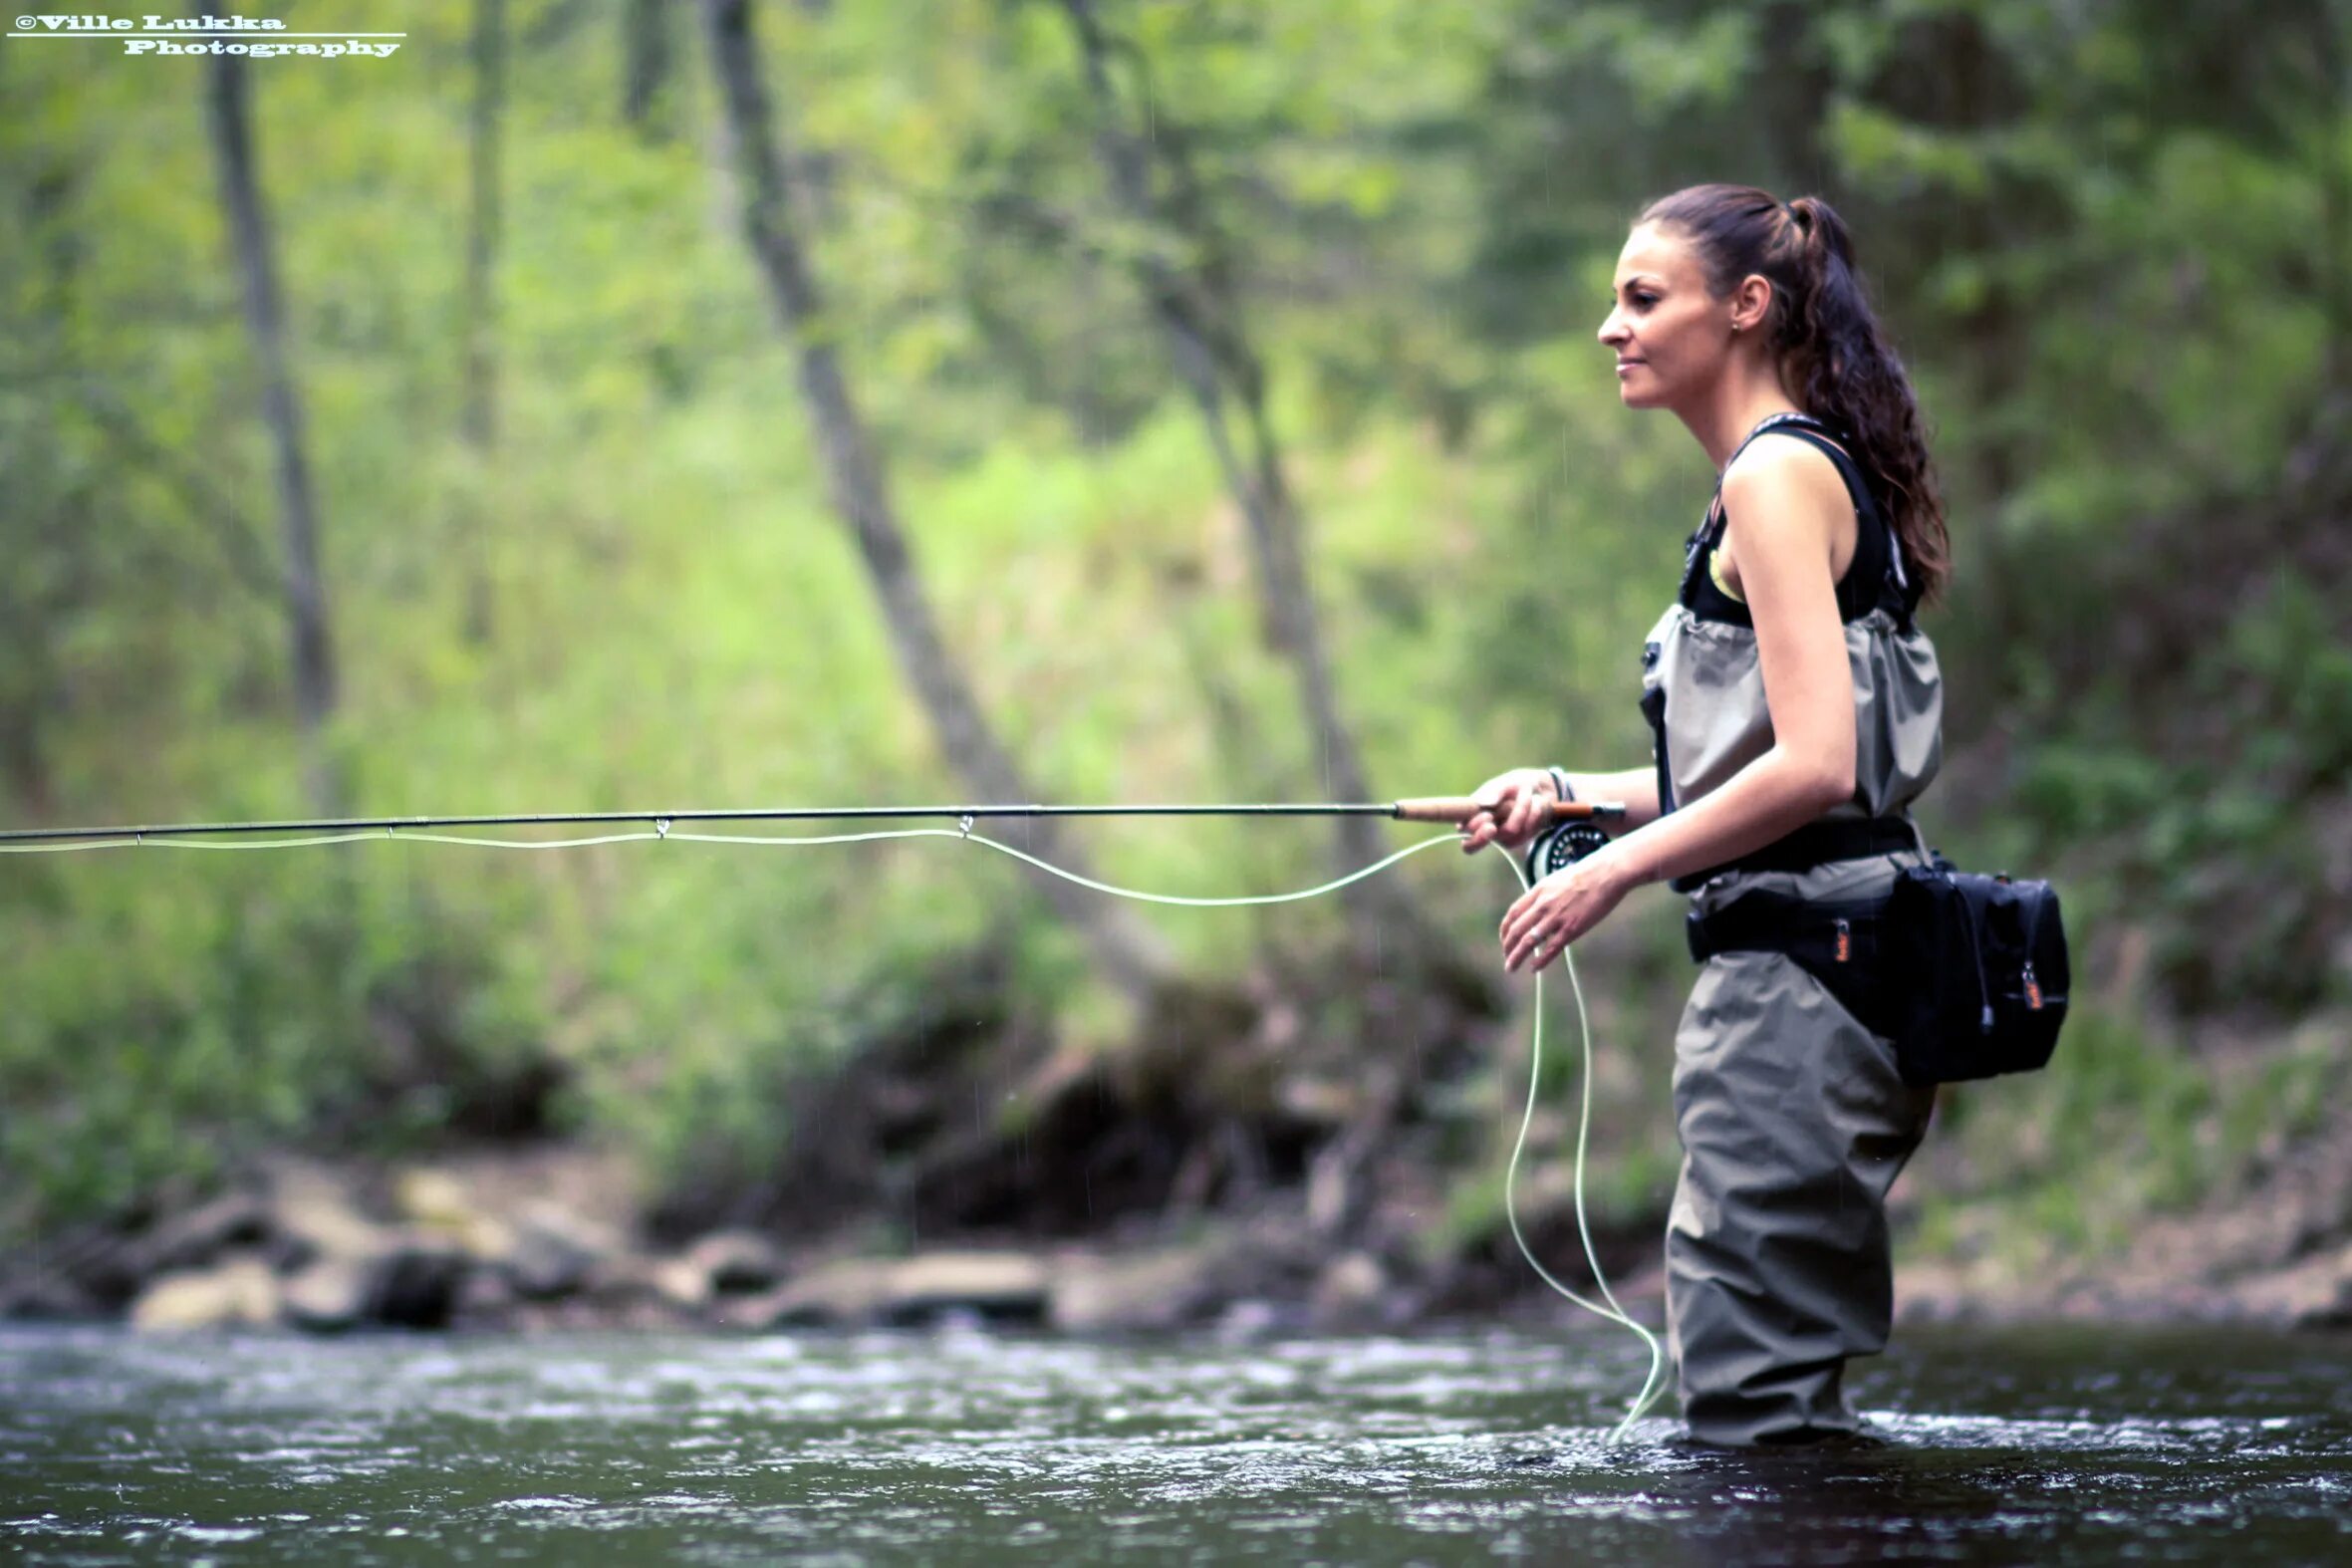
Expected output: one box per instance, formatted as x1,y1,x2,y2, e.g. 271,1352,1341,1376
0,1150,1495,1333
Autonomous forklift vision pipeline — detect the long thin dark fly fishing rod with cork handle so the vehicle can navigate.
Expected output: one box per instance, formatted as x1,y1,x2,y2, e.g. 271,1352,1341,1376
0,795,1625,844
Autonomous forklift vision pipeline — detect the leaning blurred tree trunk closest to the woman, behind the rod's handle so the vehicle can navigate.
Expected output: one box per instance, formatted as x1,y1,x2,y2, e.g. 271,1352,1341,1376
1061,0,1439,964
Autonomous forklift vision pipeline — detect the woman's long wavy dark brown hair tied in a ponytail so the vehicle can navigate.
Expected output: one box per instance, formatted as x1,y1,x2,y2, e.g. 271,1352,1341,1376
1640,185,1953,600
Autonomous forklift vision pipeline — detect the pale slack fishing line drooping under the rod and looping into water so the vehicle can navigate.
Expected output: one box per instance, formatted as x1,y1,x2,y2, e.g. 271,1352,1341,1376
13,816,1666,1443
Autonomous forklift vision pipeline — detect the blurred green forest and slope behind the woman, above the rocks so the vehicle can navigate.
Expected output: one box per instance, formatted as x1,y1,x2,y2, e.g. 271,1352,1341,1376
0,0,2352,1316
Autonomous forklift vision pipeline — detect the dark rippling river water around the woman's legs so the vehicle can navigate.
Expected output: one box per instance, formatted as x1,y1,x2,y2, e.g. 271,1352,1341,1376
0,1326,2352,1568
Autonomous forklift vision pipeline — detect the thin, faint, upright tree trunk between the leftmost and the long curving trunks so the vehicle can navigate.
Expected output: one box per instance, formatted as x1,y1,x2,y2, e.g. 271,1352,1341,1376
463,0,506,647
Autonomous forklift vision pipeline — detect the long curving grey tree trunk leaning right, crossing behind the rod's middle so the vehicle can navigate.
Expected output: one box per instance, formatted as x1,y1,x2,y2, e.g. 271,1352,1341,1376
703,0,1169,1008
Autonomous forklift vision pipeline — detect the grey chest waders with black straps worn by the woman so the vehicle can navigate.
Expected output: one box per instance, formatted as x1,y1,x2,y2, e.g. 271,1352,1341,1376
1642,416,1943,1445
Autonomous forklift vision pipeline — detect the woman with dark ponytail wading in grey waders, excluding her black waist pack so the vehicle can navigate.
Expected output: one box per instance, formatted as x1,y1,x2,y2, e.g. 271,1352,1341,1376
1463,185,1948,1445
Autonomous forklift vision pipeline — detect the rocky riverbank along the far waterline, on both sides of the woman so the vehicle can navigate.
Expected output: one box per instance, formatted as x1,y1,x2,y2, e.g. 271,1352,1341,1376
13,1123,2352,1335
